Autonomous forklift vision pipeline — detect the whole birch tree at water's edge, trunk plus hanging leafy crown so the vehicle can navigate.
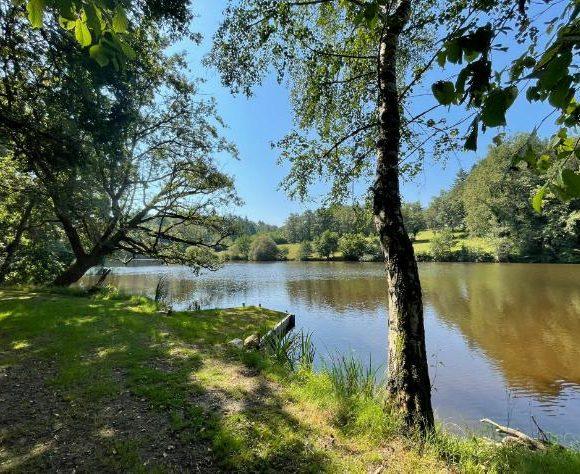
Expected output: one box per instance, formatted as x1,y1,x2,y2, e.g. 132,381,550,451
208,0,476,431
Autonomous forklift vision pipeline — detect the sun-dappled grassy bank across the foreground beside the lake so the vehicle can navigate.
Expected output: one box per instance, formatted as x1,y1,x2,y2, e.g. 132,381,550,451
0,290,580,472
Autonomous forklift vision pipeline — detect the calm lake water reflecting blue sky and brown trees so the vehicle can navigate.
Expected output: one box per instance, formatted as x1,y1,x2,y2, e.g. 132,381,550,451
81,262,580,443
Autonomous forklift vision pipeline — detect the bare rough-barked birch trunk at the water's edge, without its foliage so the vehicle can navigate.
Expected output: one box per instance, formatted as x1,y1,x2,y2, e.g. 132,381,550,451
373,2,433,433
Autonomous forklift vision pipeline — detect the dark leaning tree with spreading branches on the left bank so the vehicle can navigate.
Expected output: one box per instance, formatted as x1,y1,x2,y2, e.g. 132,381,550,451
0,5,237,285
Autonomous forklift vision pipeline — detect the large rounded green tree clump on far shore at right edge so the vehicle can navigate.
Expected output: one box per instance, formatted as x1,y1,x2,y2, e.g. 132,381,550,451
463,135,580,260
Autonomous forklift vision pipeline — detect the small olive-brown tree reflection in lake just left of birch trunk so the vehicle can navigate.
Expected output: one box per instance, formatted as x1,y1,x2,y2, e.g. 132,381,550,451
286,276,387,313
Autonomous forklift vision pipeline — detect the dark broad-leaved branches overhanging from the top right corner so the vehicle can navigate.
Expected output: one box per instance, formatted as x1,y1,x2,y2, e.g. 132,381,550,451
432,0,580,207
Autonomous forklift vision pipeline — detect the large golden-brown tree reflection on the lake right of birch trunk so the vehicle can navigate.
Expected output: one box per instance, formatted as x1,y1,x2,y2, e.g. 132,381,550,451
421,265,580,395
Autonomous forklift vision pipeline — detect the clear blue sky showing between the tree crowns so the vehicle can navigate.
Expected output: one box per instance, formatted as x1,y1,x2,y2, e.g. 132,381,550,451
174,0,553,225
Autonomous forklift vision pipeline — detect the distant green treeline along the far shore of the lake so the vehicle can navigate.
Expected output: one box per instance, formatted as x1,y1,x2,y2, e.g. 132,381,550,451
229,137,580,262
